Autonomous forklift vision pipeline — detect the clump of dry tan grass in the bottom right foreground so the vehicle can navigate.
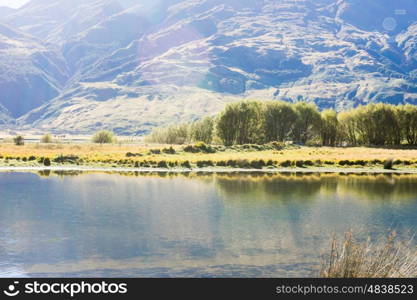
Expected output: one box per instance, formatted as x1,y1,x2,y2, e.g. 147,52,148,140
319,232,417,278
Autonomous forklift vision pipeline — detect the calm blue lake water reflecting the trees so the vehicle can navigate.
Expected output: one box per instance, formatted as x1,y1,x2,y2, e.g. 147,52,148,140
0,172,417,277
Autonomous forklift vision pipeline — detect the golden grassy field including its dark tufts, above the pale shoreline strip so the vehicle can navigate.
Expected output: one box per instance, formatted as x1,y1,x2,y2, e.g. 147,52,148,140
0,143,417,170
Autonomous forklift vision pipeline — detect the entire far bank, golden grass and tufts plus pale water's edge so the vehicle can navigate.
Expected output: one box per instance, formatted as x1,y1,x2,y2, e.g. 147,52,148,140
0,143,417,174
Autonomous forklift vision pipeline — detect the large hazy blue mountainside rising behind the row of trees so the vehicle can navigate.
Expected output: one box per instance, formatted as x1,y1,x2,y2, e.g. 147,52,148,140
0,0,417,134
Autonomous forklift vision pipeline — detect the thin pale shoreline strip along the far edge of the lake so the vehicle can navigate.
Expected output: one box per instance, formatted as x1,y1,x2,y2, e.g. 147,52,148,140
0,166,417,175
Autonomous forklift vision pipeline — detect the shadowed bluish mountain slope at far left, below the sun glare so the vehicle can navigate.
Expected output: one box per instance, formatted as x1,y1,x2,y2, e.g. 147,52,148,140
0,24,67,118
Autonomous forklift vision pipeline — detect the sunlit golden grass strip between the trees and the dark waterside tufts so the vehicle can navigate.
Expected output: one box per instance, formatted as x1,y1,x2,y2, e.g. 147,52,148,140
0,143,417,167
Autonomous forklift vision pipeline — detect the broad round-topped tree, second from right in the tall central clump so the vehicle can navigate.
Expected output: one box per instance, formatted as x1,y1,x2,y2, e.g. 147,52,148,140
263,101,297,142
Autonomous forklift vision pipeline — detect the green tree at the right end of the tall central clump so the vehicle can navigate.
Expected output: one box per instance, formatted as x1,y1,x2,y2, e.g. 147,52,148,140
293,102,320,144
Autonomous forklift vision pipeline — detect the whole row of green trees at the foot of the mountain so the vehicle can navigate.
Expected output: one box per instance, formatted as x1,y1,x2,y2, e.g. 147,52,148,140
146,101,417,146
